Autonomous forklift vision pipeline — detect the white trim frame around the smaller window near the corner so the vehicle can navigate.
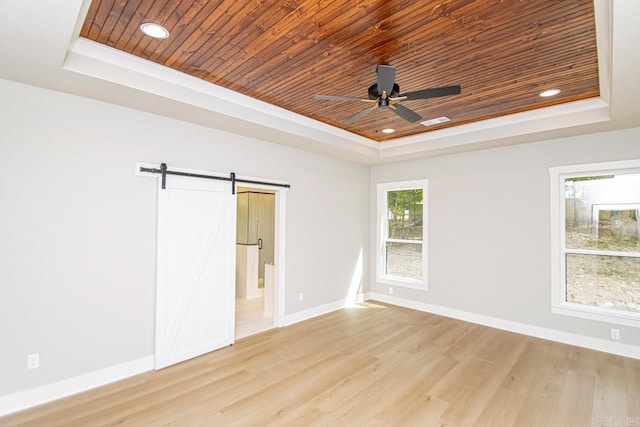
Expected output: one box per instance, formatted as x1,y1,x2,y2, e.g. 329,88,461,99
376,179,429,291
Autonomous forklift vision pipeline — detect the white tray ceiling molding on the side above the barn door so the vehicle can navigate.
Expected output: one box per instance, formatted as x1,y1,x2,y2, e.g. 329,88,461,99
62,38,378,155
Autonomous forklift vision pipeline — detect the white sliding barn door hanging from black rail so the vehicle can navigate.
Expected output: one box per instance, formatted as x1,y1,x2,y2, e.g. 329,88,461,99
155,175,236,369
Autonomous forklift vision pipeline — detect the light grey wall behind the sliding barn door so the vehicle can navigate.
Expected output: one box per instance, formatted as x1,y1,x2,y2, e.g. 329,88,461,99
0,80,369,397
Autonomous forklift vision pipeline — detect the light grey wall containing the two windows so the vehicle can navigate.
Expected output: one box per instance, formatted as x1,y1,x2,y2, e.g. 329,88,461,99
370,128,640,356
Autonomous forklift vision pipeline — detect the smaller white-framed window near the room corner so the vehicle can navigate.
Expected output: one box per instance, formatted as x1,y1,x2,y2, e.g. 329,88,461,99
377,180,427,289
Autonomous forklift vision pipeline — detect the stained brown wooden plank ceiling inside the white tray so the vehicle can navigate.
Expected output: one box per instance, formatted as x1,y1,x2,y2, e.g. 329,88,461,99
81,0,599,142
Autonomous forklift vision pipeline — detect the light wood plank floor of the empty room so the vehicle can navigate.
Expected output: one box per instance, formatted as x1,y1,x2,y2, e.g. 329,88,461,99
0,302,640,427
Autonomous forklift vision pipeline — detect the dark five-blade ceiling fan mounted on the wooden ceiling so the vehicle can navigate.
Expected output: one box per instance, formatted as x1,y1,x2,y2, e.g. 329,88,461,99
314,65,460,125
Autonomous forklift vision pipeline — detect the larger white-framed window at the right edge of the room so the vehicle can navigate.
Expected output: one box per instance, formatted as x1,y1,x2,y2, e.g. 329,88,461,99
550,160,640,326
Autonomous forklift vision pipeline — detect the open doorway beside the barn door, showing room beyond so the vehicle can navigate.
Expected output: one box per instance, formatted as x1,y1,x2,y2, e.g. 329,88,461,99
235,187,281,339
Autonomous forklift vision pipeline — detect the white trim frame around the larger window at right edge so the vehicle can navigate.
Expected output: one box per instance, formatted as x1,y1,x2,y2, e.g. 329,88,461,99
549,160,640,327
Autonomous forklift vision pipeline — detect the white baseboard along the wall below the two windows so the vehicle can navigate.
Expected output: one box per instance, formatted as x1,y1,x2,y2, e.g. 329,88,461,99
364,292,640,359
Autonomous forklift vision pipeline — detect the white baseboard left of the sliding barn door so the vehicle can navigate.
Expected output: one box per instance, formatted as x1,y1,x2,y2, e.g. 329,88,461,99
0,356,154,416
